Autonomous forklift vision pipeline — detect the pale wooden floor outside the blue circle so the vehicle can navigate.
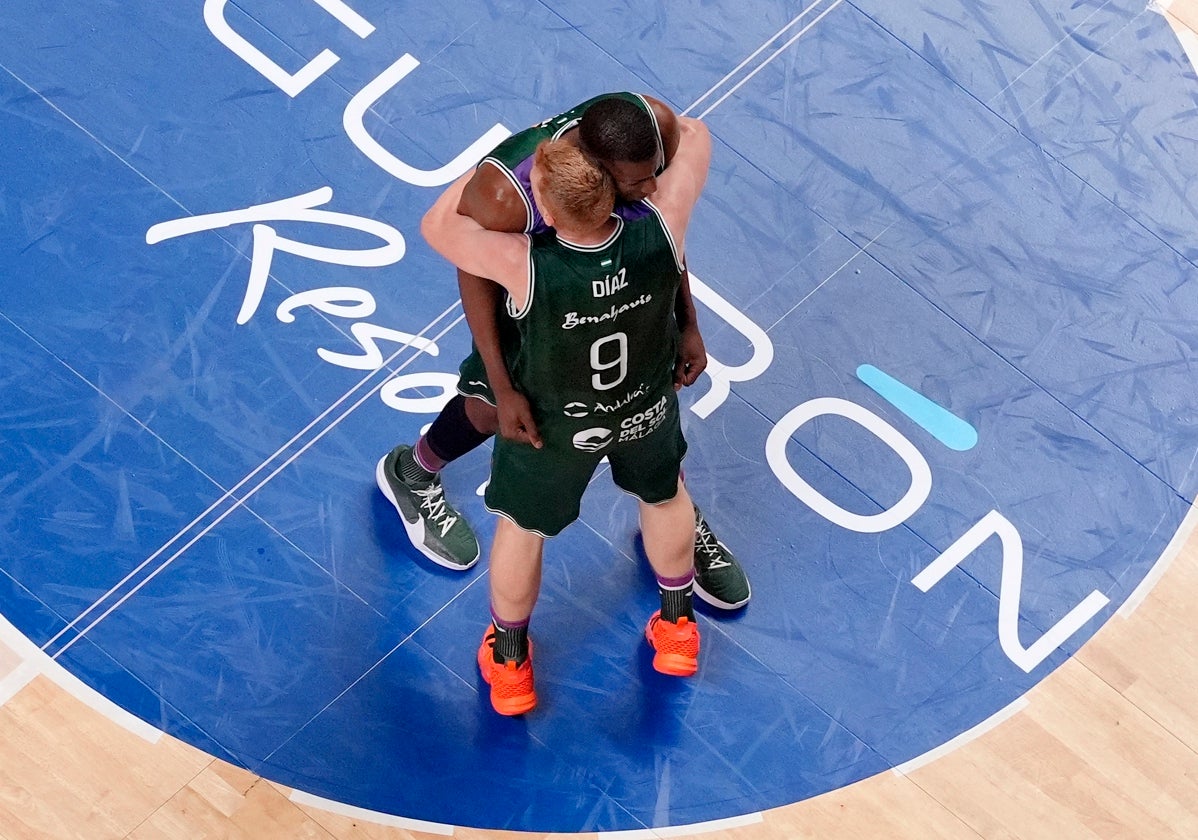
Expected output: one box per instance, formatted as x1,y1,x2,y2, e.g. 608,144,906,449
0,6,1198,840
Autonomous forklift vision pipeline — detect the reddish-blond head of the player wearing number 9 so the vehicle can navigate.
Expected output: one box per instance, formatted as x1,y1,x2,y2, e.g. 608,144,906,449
531,140,616,231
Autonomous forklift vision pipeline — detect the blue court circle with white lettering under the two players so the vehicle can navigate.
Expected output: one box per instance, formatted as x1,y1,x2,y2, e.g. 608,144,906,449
0,0,1198,832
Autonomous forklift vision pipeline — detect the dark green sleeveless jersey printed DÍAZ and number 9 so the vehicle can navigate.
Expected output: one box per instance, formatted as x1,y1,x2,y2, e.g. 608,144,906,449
504,203,682,430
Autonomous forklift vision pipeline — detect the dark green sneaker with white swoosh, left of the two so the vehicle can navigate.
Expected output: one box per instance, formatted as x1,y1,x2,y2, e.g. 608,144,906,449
375,445,479,572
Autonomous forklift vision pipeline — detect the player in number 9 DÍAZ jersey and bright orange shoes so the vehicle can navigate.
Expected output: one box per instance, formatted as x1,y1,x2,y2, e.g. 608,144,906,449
422,119,712,715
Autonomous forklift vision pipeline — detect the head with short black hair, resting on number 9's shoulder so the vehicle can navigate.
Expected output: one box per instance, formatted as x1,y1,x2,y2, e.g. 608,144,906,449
579,96,661,201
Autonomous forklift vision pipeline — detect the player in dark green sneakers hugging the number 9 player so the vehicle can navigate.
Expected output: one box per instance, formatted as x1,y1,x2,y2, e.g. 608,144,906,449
376,92,751,610
